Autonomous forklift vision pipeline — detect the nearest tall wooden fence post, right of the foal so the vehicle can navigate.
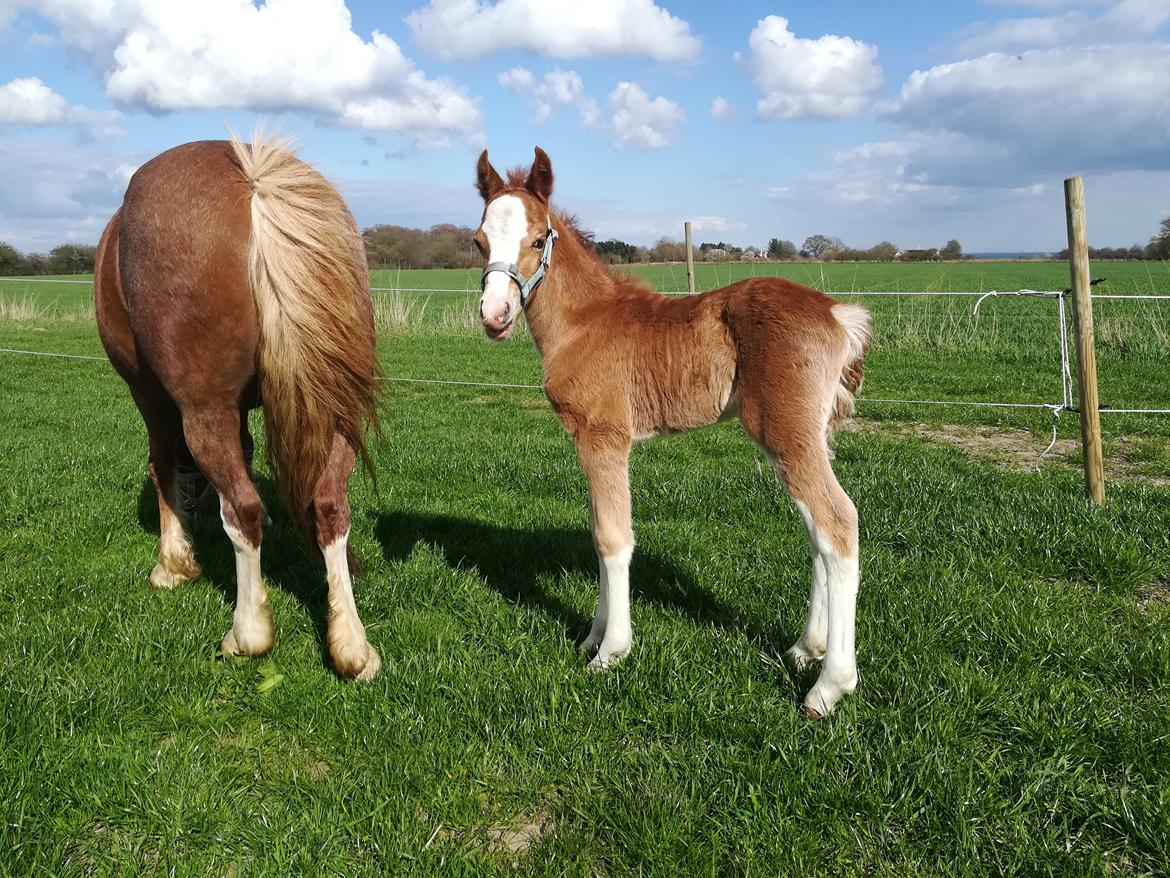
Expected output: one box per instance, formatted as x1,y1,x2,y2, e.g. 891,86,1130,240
1065,177,1104,503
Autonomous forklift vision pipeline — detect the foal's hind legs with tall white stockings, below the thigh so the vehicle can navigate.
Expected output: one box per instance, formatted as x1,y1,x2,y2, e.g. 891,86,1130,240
769,442,860,716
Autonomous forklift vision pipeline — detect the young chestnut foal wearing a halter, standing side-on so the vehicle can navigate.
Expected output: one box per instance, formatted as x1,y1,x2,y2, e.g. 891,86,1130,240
475,148,869,716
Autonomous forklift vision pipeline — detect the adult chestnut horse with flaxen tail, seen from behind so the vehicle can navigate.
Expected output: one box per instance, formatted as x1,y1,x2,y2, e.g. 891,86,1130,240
94,133,381,680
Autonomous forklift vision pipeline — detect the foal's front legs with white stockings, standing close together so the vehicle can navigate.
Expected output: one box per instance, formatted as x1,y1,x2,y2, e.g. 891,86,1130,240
577,432,634,671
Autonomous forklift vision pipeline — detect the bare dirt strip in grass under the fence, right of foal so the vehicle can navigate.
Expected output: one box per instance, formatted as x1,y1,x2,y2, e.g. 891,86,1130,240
844,418,1170,486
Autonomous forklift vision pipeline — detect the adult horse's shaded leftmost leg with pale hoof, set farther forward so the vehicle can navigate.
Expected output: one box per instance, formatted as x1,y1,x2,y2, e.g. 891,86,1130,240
133,391,201,589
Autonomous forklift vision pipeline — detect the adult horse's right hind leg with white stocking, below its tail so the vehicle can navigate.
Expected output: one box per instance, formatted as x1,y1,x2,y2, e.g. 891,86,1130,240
312,434,381,680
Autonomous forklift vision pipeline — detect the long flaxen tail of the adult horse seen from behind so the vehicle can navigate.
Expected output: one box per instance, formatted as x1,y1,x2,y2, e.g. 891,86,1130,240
225,131,378,527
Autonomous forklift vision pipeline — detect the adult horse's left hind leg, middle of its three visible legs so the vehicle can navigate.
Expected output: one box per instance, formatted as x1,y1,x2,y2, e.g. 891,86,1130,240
183,407,274,656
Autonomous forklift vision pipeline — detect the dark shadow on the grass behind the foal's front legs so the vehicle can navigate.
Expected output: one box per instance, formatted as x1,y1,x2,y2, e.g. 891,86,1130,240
374,512,765,643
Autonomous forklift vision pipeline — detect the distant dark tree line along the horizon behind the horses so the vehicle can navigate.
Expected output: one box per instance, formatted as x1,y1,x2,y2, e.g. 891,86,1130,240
0,217,1170,276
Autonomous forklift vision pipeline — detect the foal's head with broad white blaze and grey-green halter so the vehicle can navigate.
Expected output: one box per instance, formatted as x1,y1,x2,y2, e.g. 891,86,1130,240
475,146,557,341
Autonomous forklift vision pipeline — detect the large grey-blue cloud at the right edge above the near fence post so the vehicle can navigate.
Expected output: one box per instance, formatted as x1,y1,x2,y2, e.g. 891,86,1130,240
879,44,1170,176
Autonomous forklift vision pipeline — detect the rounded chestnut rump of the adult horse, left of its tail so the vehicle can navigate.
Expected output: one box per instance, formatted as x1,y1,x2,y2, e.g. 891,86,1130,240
108,140,257,406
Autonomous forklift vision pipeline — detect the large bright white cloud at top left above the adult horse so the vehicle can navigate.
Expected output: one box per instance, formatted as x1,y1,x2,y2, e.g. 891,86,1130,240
2,0,482,143
